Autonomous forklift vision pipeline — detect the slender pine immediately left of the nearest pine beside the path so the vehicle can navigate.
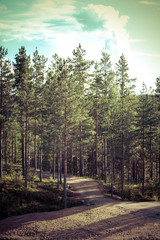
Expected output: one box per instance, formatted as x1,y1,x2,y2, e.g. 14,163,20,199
45,54,66,180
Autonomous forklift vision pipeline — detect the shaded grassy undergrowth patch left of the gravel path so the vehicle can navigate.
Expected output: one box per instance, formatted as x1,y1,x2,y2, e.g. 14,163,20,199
0,174,82,219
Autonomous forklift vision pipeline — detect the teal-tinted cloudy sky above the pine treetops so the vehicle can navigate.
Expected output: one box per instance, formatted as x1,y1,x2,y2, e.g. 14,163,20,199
0,0,160,91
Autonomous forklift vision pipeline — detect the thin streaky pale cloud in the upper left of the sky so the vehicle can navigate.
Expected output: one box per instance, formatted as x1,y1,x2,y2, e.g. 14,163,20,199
0,0,78,41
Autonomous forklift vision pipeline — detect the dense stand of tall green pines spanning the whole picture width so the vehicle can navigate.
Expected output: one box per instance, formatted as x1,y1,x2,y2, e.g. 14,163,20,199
0,45,160,199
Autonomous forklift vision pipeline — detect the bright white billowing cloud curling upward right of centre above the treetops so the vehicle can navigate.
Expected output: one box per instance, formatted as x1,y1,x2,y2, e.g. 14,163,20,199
47,4,130,62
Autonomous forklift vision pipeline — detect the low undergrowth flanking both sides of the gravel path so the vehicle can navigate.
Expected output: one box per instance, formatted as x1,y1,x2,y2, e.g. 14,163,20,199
0,164,160,220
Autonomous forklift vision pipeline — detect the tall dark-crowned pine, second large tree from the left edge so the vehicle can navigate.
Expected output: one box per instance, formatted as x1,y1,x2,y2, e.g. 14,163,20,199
14,47,32,187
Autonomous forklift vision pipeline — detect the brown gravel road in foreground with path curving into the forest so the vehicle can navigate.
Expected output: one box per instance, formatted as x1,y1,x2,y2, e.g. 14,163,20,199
0,177,160,240
